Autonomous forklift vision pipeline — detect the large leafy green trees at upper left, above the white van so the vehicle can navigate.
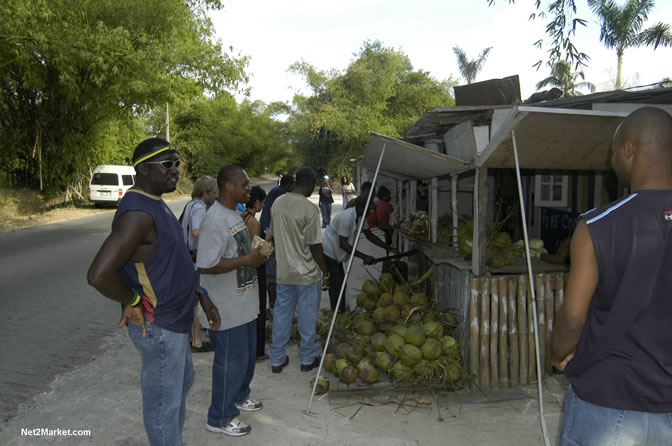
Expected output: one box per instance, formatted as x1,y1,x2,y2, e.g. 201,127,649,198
0,0,247,189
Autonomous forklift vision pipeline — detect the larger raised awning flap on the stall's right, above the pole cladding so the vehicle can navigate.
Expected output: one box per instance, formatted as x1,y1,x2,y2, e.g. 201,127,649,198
476,106,627,170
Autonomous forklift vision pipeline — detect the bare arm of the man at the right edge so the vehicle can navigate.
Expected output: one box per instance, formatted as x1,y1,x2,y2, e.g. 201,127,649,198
551,220,599,370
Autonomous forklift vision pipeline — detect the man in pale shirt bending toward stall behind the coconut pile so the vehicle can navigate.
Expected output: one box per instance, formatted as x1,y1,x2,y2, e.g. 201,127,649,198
322,195,389,312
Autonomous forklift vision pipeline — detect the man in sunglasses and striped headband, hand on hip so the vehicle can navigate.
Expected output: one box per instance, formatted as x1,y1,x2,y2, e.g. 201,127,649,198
87,138,219,445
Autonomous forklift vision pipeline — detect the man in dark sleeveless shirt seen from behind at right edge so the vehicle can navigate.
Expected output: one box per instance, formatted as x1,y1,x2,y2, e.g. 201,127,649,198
551,107,672,446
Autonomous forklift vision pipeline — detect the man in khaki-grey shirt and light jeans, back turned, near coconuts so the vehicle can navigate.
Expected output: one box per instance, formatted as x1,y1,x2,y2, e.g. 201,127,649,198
268,167,329,373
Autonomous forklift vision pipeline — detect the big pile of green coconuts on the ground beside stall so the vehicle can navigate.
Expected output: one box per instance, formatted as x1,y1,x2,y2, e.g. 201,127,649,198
317,268,466,389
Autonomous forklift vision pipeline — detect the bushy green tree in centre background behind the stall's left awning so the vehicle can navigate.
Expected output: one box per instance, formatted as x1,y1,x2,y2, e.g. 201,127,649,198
288,41,455,175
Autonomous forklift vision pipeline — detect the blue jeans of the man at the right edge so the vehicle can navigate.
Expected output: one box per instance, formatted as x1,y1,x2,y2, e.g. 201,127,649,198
558,386,672,446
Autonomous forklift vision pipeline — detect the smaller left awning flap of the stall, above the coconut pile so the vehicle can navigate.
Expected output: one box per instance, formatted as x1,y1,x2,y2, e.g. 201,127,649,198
362,132,473,180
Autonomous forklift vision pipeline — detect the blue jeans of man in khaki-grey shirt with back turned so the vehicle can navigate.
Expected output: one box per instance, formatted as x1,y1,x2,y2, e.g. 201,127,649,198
268,281,322,366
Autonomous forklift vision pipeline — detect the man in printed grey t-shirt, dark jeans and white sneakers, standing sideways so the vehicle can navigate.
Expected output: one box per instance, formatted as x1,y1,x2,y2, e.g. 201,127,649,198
196,165,266,436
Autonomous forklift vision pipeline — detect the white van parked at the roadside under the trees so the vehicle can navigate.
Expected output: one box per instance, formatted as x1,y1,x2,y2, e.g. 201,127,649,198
89,164,135,207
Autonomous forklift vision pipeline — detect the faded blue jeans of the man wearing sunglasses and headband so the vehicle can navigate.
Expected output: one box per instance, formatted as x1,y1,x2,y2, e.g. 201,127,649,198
127,320,194,446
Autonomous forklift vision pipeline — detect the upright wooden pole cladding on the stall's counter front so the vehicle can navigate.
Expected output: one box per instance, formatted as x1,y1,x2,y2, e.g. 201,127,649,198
464,273,567,389
